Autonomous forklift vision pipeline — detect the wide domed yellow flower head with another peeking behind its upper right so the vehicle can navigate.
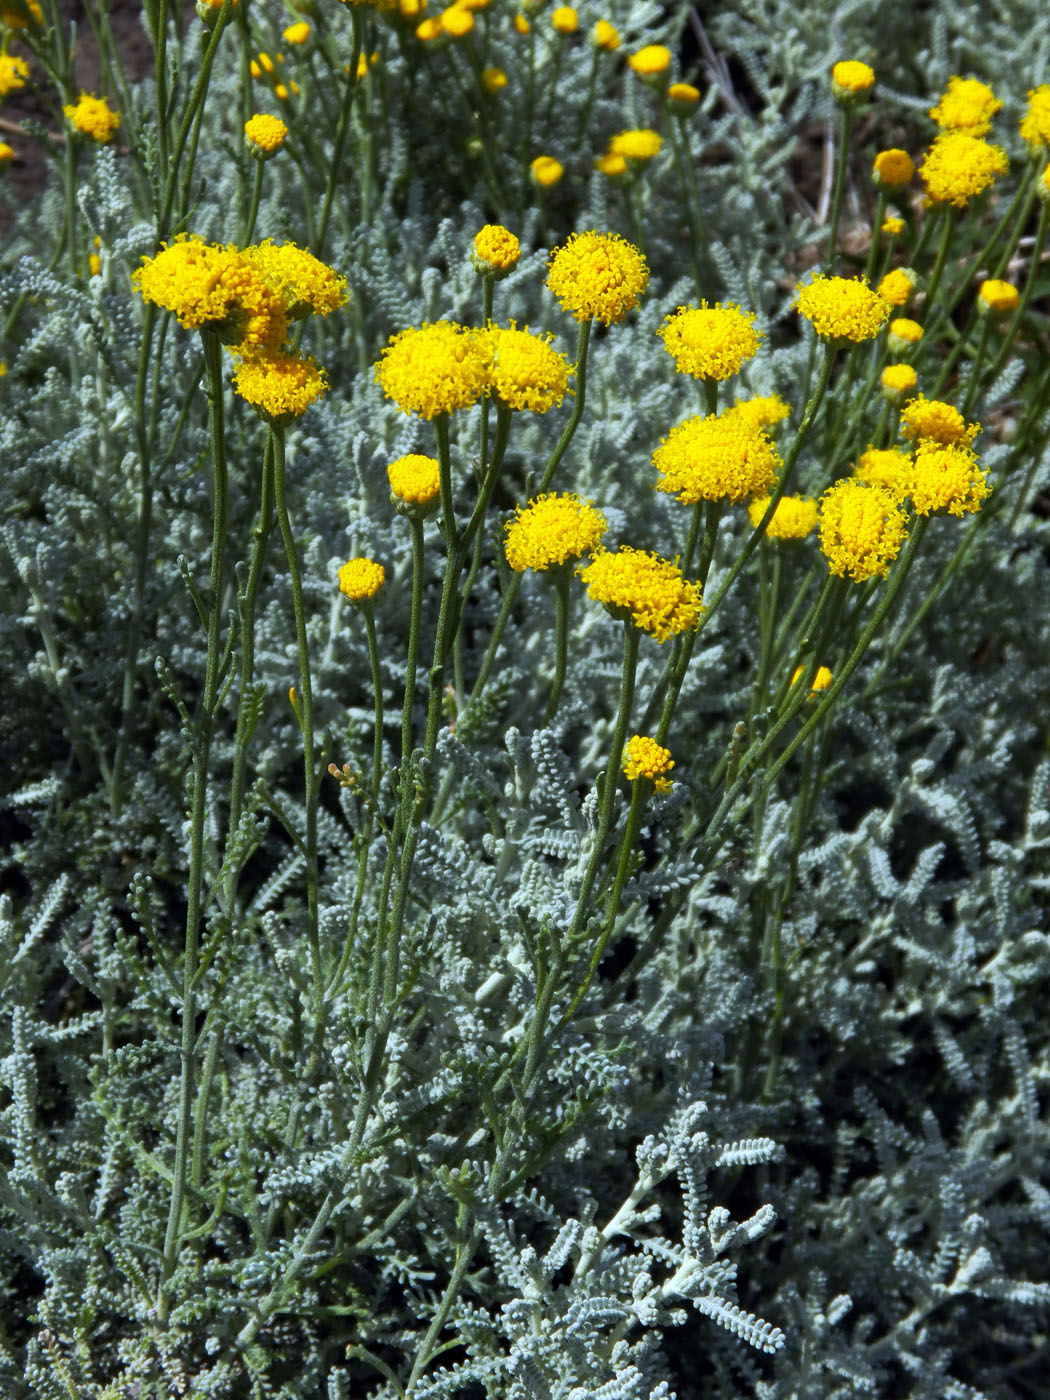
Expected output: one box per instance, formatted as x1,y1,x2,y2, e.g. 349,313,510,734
652,409,781,505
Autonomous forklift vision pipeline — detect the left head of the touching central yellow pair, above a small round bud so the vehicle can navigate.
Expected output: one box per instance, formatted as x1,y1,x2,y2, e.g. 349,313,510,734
375,321,489,419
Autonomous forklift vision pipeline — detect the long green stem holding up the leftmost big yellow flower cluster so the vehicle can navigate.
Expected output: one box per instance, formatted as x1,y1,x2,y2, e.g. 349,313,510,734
157,327,230,1326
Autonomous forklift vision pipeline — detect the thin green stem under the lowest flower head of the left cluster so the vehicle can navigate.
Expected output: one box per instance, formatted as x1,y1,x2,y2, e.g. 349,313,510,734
270,423,325,1077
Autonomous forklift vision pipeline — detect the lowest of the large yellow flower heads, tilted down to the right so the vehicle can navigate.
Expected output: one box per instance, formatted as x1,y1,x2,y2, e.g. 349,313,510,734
577,545,704,641
